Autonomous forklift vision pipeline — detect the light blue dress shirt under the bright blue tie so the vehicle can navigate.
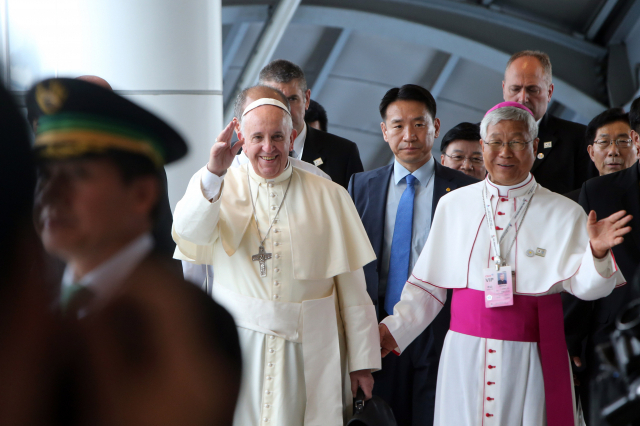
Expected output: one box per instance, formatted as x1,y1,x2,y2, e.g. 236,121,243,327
378,157,436,296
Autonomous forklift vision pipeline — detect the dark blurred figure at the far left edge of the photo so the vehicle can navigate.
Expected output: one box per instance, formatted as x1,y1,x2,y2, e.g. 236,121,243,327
0,82,60,425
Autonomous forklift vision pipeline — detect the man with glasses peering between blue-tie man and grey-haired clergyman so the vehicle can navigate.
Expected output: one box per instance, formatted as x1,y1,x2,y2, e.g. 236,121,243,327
440,123,487,180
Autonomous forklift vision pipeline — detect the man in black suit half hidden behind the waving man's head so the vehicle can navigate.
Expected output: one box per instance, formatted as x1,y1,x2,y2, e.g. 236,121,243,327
260,59,364,188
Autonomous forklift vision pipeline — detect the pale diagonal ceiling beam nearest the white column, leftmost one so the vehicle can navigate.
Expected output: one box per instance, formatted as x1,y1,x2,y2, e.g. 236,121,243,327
224,0,301,122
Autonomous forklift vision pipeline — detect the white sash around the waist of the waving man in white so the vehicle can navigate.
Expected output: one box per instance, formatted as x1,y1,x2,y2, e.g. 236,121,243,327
212,283,343,426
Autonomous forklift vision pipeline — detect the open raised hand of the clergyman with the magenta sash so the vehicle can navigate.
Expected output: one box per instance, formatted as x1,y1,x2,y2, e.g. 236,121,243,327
587,210,633,258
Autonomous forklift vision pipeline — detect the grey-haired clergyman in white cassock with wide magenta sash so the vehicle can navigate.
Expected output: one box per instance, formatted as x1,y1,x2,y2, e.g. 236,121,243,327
380,102,631,426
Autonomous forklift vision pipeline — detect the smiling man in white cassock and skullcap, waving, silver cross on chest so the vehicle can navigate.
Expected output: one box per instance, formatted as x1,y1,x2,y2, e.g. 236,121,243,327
173,86,380,426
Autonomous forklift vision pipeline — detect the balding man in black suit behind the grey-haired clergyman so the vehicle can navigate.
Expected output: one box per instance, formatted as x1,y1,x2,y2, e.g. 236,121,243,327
502,50,597,194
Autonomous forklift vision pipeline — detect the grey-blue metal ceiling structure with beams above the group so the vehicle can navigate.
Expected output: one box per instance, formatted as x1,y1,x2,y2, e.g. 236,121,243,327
222,0,640,169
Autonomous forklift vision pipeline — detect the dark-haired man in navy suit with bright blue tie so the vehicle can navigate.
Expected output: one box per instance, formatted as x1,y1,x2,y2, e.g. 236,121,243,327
349,84,477,426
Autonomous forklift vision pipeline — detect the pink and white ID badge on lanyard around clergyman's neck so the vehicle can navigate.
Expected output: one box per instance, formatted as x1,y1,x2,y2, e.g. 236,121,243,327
482,183,538,308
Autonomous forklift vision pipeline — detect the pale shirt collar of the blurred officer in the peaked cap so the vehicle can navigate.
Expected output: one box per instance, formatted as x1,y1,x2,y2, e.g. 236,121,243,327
62,233,153,300
